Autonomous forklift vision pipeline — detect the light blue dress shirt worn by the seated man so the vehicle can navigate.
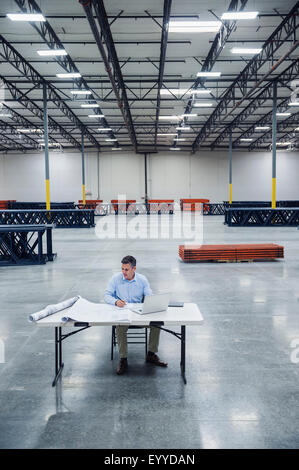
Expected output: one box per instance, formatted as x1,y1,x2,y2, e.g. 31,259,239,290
104,273,152,305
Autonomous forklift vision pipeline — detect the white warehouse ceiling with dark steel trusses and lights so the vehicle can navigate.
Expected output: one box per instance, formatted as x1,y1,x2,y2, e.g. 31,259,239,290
0,0,299,153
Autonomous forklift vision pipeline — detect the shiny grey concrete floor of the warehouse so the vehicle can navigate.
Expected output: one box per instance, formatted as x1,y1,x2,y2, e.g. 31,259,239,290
0,216,299,449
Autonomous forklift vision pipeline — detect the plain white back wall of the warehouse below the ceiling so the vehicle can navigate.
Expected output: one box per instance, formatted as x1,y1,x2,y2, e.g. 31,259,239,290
0,151,299,202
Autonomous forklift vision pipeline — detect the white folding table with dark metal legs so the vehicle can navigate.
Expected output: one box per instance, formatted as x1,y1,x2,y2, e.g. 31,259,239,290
36,303,203,387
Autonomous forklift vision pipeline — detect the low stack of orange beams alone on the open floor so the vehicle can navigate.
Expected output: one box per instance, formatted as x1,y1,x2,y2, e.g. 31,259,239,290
179,243,284,262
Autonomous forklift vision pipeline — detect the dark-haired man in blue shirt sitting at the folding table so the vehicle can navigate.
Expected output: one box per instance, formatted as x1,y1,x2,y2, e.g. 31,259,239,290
104,256,167,375
